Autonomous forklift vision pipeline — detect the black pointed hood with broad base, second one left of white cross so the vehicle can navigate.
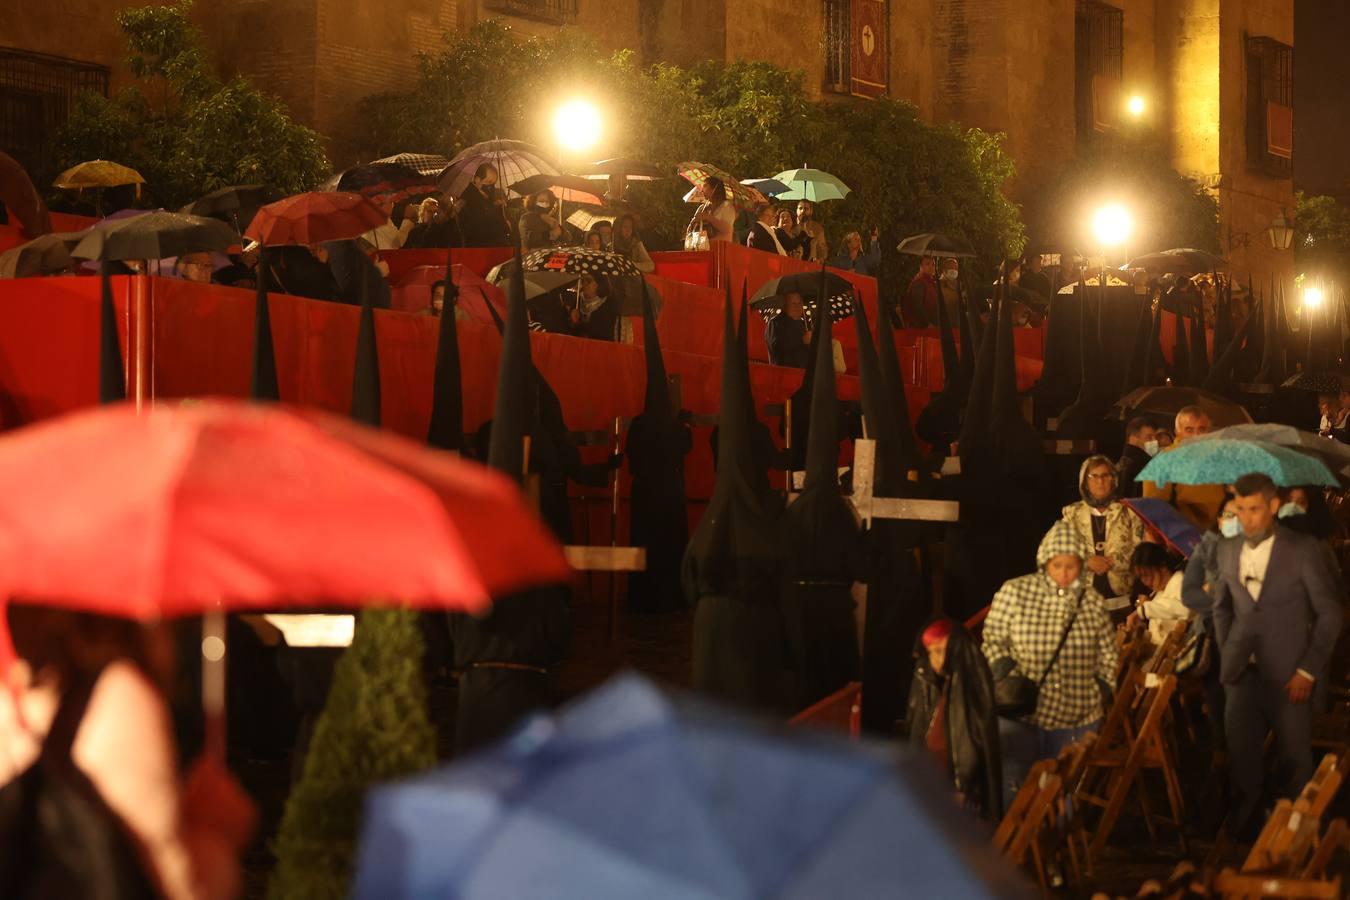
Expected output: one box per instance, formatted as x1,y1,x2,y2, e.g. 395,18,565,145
683,286,780,595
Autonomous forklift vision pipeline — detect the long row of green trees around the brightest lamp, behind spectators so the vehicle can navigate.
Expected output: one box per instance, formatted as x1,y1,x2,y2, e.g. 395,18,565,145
350,22,1023,284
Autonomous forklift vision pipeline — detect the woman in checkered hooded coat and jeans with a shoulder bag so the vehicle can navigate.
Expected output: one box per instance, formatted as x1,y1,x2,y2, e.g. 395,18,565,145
981,519,1116,806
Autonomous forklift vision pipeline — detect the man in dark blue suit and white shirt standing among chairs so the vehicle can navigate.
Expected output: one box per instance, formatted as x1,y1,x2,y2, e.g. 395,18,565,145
1214,474,1342,837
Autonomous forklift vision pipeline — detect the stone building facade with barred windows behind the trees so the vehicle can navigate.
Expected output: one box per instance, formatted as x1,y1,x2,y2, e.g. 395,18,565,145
0,0,1295,278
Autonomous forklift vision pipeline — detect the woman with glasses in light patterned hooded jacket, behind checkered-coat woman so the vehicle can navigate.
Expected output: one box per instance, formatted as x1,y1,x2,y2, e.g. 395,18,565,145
1064,456,1143,609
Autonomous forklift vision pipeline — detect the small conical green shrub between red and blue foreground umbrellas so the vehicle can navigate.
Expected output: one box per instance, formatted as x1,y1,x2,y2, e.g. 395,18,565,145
267,610,436,900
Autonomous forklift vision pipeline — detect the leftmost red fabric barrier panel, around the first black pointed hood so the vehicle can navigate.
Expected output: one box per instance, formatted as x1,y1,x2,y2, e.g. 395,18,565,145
0,277,132,428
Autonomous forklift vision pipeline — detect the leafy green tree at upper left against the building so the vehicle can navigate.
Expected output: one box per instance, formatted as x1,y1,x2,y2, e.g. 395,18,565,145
47,0,328,209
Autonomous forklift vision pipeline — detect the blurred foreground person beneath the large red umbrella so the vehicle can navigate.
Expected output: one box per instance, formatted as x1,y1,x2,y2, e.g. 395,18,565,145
0,604,255,900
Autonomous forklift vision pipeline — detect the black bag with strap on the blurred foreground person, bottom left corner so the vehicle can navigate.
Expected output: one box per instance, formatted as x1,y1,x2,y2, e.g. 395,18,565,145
0,673,157,900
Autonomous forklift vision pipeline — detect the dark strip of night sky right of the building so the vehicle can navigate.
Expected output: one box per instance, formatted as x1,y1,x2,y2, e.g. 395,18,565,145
1293,0,1350,200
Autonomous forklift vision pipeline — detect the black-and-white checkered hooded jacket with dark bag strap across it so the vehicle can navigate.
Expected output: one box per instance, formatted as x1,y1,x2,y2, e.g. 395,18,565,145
981,519,1116,730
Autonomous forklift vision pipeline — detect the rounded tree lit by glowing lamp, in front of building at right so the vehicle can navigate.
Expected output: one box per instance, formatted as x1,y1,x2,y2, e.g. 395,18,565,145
1027,140,1223,255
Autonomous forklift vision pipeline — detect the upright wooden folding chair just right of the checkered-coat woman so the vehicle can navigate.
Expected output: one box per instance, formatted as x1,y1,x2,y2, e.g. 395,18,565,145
1075,668,1185,857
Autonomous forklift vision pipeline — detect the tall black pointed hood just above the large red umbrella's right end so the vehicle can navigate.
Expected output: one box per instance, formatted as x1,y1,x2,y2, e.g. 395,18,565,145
487,237,536,482
